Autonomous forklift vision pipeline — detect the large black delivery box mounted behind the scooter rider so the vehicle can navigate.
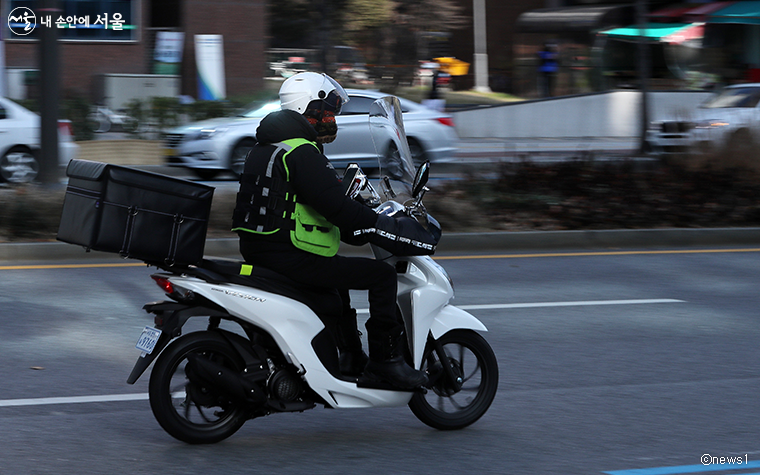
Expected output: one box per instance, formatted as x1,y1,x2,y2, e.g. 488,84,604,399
57,160,214,265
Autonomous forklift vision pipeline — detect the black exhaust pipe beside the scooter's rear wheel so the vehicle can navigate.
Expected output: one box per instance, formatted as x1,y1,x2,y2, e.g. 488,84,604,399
185,354,267,404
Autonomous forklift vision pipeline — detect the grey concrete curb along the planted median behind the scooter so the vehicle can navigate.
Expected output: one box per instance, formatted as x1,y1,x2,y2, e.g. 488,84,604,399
0,228,760,262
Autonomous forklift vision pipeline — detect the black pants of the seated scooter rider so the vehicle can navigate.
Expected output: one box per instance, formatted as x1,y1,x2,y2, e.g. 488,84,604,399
240,239,404,351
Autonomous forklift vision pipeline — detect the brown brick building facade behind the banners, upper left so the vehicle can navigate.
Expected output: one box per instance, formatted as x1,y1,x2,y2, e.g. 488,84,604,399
2,0,267,101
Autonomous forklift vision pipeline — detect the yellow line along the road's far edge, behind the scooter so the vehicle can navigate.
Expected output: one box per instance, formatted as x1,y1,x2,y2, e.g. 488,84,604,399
0,248,760,271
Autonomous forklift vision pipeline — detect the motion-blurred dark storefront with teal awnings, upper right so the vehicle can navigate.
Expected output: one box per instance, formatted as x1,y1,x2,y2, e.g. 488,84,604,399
514,1,760,97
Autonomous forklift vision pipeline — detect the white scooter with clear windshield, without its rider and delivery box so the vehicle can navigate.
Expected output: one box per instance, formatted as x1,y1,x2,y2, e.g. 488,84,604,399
128,97,498,443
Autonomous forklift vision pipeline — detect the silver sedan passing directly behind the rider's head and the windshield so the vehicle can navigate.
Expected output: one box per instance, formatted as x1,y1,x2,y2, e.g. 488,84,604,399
165,89,457,179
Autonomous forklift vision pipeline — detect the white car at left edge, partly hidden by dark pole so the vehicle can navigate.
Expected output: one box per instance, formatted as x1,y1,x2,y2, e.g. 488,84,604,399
0,97,79,183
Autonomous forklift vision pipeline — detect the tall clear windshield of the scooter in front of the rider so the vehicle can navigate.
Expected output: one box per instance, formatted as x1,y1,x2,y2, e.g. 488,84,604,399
369,96,414,203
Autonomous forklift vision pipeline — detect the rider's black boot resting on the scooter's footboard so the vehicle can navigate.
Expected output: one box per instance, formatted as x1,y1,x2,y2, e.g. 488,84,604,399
364,332,428,389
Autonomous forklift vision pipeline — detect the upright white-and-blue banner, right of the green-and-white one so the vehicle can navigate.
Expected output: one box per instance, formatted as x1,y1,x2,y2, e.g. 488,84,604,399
195,35,227,101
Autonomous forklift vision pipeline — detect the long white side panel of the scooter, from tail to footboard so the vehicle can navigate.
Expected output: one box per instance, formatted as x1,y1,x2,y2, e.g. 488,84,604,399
160,276,412,408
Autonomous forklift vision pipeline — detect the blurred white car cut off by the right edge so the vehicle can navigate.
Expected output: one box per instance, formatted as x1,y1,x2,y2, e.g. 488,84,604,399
647,83,760,156
